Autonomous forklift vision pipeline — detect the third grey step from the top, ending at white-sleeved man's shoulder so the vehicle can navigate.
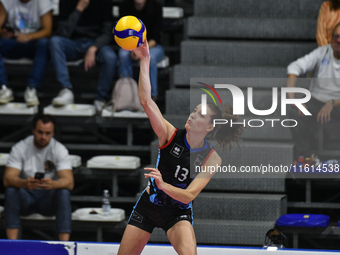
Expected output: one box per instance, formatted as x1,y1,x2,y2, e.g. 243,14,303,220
181,40,317,67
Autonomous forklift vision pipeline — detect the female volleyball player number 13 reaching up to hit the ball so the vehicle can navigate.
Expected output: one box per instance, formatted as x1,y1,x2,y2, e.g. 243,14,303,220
118,40,242,255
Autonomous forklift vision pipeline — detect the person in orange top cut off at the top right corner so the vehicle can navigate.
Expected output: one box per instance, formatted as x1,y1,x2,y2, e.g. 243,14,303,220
316,0,340,46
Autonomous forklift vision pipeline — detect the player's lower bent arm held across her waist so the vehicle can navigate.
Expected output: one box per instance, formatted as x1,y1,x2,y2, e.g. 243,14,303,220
145,151,222,204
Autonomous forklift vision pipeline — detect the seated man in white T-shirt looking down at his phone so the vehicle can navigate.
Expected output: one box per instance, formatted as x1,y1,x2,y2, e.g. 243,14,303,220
4,114,74,241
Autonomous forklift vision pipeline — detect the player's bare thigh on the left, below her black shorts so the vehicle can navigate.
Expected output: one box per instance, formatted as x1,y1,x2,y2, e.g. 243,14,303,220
118,225,151,255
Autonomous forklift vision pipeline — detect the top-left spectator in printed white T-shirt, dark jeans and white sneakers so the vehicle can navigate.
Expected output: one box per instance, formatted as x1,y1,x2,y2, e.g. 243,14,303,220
0,0,52,106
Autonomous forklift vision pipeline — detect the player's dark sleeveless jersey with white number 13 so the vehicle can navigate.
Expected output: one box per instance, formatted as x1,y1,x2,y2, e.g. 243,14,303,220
149,129,215,209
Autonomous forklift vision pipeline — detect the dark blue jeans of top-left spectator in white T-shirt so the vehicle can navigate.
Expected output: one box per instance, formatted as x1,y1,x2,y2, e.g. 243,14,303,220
0,38,49,89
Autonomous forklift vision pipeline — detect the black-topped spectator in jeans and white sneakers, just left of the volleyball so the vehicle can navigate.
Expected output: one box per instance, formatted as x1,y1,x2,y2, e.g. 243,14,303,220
50,0,117,110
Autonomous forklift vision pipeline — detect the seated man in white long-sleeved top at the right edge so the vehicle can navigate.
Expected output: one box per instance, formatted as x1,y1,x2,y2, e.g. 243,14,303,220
287,23,340,158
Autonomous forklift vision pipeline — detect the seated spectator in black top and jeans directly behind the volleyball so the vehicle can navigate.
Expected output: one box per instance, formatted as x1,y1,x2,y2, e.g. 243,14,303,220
119,0,164,100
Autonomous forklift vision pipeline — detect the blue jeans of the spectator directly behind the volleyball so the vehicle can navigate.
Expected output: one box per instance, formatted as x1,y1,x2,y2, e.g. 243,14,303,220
118,44,164,96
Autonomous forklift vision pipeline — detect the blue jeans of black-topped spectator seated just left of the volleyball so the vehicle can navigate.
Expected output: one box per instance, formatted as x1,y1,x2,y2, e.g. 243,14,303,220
50,36,117,100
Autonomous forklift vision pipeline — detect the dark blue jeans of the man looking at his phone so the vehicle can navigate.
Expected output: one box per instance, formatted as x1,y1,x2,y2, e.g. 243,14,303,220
5,187,72,233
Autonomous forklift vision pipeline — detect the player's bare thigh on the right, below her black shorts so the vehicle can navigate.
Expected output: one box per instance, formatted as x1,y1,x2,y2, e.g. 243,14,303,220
166,220,197,255
